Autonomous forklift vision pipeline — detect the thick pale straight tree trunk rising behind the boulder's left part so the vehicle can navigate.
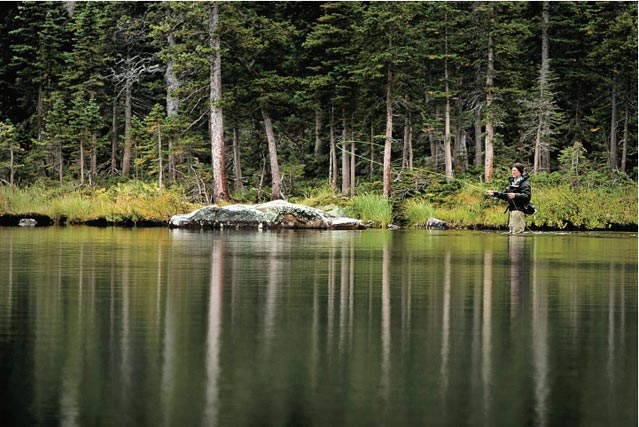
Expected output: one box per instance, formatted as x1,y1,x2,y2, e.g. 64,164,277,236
209,3,228,203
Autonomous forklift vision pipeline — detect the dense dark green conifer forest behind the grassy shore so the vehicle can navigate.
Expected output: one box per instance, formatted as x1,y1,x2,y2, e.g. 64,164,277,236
0,1,638,229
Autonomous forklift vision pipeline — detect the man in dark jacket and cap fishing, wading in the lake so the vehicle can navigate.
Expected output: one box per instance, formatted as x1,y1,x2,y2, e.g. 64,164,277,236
486,163,532,233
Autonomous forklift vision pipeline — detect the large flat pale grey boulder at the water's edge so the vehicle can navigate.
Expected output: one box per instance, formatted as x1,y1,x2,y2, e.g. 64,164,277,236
169,200,366,230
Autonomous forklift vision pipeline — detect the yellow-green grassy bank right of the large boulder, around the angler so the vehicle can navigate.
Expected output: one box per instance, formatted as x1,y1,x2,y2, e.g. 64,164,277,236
300,173,638,230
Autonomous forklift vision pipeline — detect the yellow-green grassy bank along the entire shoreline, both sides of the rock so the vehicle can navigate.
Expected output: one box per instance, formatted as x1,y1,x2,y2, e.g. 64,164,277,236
0,175,638,230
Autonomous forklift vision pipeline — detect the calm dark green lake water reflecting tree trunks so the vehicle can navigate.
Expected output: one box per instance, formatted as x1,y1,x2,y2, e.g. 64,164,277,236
0,227,638,427
